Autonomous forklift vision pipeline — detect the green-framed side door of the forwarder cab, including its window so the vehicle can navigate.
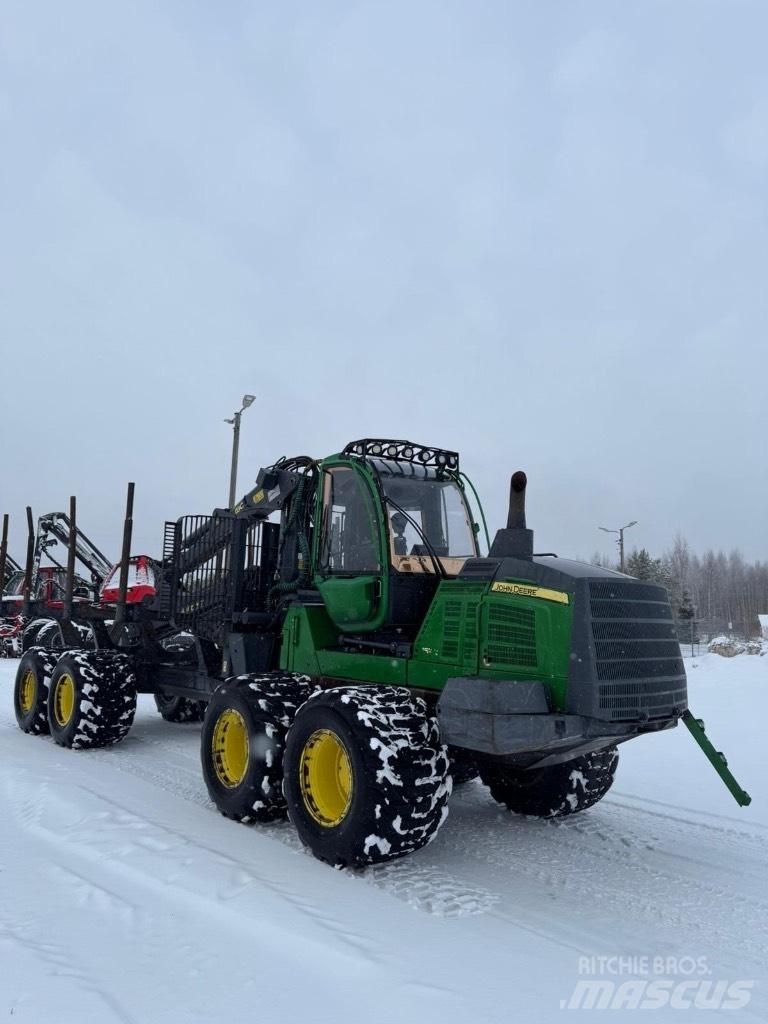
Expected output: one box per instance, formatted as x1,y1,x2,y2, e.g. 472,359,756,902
314,464,387,632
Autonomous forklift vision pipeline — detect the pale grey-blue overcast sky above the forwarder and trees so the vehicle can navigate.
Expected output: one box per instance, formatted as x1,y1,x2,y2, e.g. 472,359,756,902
0,0,768,559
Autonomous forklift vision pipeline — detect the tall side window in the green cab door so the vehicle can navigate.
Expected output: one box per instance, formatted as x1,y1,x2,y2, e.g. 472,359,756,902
319,466,381,575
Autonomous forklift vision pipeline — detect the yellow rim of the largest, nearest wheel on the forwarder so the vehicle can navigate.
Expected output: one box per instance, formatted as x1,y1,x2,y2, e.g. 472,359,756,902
299,729,352,828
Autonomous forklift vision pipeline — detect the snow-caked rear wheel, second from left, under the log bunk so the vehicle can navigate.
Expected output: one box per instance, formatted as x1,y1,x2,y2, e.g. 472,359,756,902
48,650,136,750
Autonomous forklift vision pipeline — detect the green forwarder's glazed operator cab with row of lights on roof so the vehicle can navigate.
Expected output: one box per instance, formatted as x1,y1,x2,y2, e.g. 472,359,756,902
314,440,478,637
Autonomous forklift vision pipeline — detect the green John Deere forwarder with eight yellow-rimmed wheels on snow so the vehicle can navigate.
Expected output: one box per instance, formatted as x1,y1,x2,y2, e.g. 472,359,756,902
14,438,750,866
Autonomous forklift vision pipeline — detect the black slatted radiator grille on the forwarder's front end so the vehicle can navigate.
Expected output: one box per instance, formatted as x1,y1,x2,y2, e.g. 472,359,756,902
590,581,687,721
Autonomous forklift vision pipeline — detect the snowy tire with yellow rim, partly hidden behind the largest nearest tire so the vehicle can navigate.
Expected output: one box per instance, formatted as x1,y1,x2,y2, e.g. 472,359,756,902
200,673,311,824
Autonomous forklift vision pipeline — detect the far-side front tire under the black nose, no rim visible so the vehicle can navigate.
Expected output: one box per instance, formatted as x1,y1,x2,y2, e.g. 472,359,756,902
480,746,618,818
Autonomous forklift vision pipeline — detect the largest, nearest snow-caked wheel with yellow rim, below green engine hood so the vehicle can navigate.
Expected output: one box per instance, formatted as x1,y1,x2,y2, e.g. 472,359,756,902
284,686,452,867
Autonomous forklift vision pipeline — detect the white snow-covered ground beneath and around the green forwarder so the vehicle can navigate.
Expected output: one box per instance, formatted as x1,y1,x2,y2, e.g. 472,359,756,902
0,654,768,1024
